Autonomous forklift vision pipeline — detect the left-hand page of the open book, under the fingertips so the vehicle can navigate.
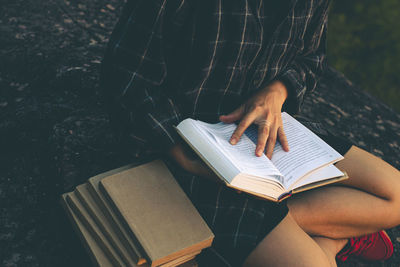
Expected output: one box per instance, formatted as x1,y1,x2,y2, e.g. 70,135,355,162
195,121,283,183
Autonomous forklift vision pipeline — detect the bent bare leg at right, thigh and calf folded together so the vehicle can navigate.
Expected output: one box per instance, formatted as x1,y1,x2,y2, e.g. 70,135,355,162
288,146,400,239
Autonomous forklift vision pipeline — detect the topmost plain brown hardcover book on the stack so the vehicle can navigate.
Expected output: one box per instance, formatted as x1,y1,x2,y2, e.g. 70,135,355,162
100,160,214,266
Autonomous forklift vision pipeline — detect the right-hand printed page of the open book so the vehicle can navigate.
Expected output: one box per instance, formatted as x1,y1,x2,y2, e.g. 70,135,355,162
271,112,343,187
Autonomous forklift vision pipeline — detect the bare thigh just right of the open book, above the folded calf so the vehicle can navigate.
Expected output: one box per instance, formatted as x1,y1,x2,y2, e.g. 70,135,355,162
336,146,400,200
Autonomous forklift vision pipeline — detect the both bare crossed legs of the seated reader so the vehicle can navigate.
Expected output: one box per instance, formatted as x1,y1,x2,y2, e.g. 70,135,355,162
244,146,400,266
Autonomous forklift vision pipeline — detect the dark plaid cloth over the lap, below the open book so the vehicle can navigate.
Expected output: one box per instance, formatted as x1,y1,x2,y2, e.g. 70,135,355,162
166,161,288,266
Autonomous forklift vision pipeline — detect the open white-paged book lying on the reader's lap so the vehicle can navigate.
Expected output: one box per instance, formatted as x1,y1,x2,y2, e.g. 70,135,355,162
176,112,347,201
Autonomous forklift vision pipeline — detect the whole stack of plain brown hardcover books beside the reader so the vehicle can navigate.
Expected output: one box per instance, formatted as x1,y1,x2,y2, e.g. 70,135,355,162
61,160,214,266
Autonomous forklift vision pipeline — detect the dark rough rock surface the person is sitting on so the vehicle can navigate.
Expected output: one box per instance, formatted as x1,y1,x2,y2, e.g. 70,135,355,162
0,0,400,266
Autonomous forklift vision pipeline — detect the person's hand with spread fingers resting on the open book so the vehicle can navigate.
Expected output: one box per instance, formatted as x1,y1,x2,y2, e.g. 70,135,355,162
220,81,289,159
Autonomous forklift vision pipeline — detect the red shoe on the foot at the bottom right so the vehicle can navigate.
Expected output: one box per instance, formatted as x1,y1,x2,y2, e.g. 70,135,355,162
336,230,393,261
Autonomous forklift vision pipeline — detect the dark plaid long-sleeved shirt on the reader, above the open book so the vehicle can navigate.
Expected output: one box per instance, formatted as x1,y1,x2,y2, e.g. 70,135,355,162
101,0,329,149
